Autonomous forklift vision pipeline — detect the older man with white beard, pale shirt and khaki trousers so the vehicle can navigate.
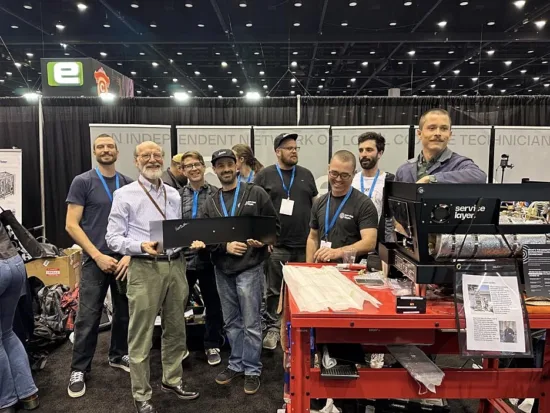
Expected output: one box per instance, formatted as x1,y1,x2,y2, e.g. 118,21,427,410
105,141,199,413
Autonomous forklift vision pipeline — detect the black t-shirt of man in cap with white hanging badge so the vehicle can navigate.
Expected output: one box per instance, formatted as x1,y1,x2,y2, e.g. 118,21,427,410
254,165,318,248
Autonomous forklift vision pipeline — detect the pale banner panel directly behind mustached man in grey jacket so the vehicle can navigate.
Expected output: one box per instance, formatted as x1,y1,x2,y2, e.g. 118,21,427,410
414,126,491,174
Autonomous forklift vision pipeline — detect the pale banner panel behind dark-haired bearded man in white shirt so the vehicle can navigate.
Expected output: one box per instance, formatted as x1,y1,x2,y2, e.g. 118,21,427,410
332,125,410,173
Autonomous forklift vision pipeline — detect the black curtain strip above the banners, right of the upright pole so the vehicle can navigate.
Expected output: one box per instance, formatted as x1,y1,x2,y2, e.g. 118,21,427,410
300,96,550,126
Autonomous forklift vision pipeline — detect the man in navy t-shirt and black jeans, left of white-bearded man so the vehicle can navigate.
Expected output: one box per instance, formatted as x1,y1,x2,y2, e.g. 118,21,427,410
65,134,132,398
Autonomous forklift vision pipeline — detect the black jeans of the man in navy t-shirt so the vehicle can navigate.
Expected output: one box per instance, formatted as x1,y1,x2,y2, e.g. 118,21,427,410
71,257,130,372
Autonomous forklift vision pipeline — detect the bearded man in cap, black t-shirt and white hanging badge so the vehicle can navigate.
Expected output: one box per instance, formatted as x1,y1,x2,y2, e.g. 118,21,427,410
254,133,318,350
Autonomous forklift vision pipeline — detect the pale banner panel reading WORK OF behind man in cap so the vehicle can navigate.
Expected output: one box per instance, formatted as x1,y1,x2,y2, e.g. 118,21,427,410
254,126,330,194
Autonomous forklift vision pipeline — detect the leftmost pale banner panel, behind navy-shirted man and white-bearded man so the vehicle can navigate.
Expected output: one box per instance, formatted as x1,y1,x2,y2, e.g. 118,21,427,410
90,123,172,179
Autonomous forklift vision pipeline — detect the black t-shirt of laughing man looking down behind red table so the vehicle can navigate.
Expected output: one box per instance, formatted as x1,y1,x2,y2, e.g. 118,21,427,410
310,188,378,248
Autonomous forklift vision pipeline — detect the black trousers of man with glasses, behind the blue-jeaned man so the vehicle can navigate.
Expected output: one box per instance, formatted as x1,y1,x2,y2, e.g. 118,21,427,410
187,267,223,350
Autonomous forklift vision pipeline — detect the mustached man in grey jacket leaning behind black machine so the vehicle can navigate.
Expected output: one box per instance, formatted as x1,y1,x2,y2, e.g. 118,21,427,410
395,109,487,184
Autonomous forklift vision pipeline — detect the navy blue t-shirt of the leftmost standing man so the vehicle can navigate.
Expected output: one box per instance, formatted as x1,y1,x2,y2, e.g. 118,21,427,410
66,169,133,254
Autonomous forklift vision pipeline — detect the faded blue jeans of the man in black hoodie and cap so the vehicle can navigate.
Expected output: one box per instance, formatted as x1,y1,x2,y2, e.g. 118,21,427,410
215,263,264,376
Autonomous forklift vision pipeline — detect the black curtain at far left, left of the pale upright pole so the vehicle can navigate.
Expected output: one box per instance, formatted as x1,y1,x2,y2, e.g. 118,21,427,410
0,98,42,230
